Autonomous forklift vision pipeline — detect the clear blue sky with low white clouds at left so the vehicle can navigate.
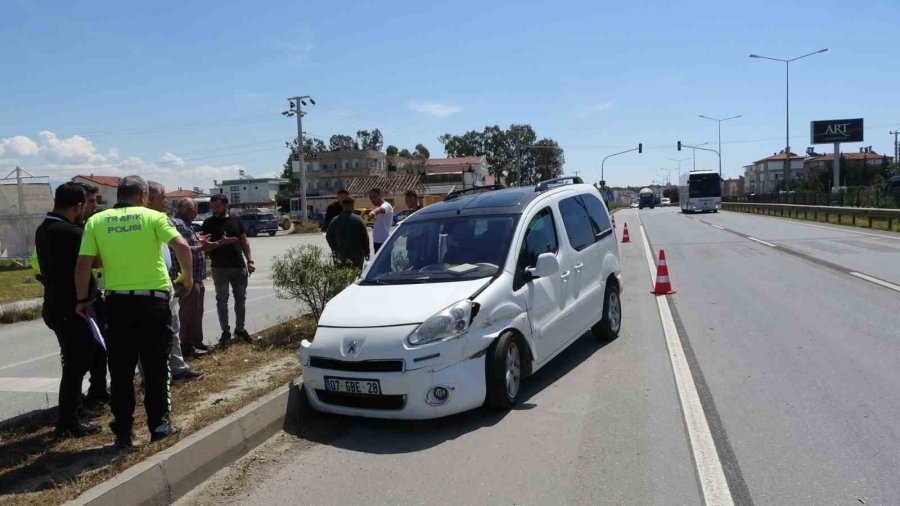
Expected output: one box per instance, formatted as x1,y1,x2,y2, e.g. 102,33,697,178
0,0,900,189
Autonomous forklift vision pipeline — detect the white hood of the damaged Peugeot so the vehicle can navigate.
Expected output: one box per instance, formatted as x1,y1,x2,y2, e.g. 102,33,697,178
319,278,490,327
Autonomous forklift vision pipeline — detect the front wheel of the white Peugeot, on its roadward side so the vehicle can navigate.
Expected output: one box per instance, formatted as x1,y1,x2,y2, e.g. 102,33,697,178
485,332,523,410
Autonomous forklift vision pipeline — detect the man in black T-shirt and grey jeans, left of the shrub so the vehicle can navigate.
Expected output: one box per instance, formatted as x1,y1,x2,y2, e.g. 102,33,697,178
202,194,256,346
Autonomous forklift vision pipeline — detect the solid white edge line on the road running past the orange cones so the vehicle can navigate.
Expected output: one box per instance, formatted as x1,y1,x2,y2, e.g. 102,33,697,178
640,225,734,505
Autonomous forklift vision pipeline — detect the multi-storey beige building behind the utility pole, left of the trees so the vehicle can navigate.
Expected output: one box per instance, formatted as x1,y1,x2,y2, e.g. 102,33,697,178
293,149,387,196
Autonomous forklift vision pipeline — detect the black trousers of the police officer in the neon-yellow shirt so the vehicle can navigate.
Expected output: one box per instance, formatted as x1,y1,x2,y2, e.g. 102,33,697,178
105,294,172,435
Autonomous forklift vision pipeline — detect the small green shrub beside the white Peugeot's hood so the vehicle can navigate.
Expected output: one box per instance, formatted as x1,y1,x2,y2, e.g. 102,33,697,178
272,244,360,321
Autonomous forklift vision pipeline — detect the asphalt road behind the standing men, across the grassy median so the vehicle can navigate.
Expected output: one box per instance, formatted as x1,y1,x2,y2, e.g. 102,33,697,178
0,231,327,423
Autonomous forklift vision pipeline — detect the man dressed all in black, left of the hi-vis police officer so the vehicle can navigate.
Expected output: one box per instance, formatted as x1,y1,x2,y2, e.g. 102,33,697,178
34,183,106,437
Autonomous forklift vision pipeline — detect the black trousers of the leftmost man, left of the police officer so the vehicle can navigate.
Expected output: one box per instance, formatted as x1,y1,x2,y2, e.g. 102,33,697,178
44,312,100,429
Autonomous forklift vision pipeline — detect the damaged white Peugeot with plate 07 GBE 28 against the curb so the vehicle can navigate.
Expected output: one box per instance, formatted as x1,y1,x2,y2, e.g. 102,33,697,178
300,177,622,419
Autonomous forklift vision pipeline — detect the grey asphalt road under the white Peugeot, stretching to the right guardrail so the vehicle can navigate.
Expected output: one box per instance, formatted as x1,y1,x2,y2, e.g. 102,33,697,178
180,208,900,505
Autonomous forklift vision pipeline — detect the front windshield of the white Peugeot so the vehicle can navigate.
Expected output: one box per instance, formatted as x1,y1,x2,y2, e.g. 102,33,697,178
363,216,516,285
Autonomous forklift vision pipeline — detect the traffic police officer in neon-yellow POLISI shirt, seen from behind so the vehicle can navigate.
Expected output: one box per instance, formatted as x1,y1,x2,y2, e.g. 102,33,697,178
75,176,193,448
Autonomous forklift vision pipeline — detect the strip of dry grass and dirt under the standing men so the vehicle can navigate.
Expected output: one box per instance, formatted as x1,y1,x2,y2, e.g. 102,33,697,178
0,318,315,505
